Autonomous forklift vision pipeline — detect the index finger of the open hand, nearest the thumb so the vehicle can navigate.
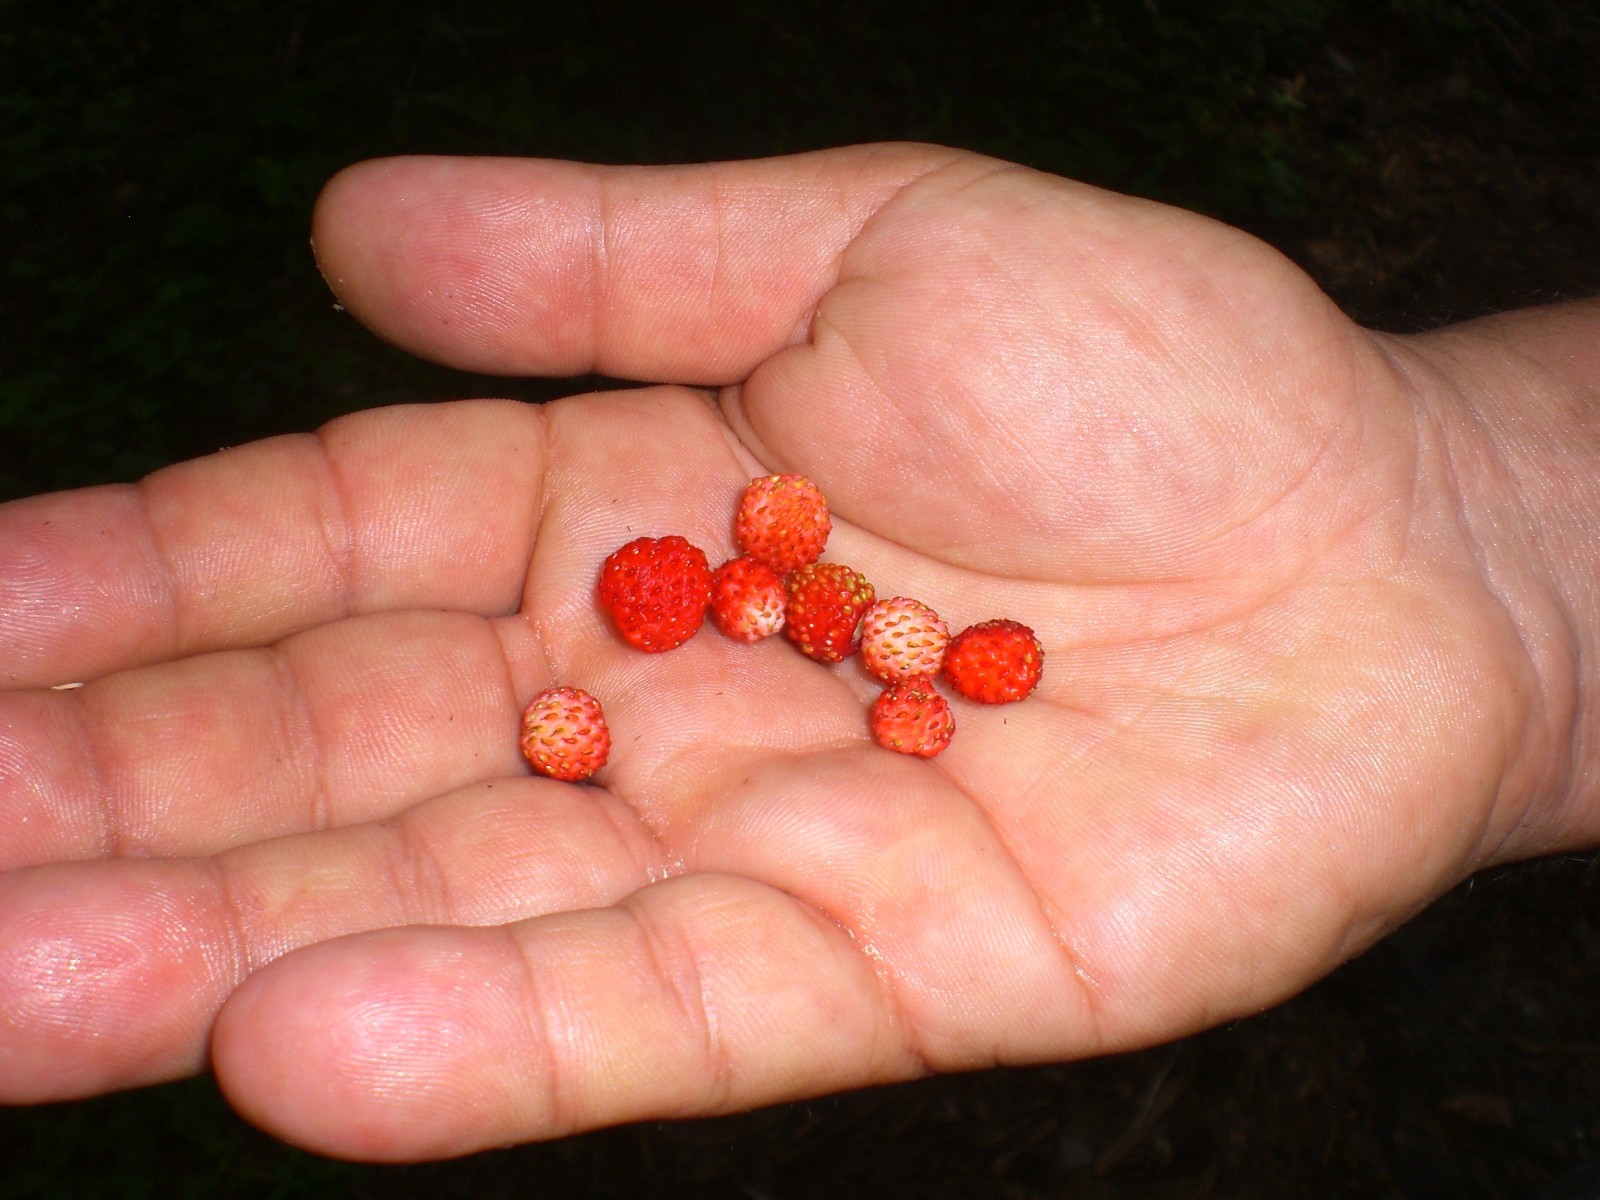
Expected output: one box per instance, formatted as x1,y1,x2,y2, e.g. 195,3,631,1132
0,402,547,688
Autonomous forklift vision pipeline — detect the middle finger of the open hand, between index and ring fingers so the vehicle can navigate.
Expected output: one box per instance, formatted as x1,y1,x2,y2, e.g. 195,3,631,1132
0,613,531,869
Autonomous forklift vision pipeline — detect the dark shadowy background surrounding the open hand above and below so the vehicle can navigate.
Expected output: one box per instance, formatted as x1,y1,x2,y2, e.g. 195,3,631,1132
0,0,1600,1200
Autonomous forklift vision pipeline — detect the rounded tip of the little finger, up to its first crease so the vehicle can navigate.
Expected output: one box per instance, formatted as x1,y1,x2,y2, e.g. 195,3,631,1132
211,928,528,1162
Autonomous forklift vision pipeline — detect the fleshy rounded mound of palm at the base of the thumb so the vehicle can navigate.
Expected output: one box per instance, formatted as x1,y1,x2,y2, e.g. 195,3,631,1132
726,160,1386,584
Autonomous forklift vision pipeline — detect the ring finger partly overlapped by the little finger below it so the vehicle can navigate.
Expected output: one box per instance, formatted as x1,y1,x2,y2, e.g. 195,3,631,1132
0,778,666,1104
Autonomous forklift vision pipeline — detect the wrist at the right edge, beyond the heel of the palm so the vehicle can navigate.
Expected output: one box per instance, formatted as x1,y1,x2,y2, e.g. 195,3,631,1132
1390,301,1600,859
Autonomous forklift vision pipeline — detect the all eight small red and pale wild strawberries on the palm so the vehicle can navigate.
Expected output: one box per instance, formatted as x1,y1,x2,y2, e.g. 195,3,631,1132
522,475,1045,781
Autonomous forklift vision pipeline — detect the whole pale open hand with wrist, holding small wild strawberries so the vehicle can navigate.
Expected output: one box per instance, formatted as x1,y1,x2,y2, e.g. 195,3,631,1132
0,147,1600,1160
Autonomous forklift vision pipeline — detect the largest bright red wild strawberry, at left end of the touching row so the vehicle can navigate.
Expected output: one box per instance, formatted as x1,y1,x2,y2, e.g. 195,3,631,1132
600,536,710,653
